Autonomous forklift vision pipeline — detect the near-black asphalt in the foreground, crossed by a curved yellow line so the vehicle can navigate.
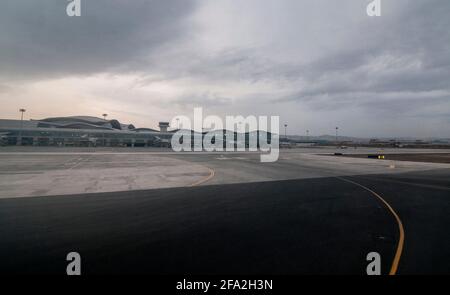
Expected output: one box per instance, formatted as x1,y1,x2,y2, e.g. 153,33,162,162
0,168,450,274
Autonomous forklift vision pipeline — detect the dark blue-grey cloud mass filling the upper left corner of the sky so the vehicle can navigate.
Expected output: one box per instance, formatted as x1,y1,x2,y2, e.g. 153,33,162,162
0,0,195,79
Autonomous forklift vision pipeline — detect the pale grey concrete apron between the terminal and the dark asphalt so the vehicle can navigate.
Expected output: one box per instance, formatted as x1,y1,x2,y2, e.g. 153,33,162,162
0,147,450,198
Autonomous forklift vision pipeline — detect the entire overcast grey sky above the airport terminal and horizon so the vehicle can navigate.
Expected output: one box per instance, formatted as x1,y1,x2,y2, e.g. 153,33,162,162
0,0,450,137
